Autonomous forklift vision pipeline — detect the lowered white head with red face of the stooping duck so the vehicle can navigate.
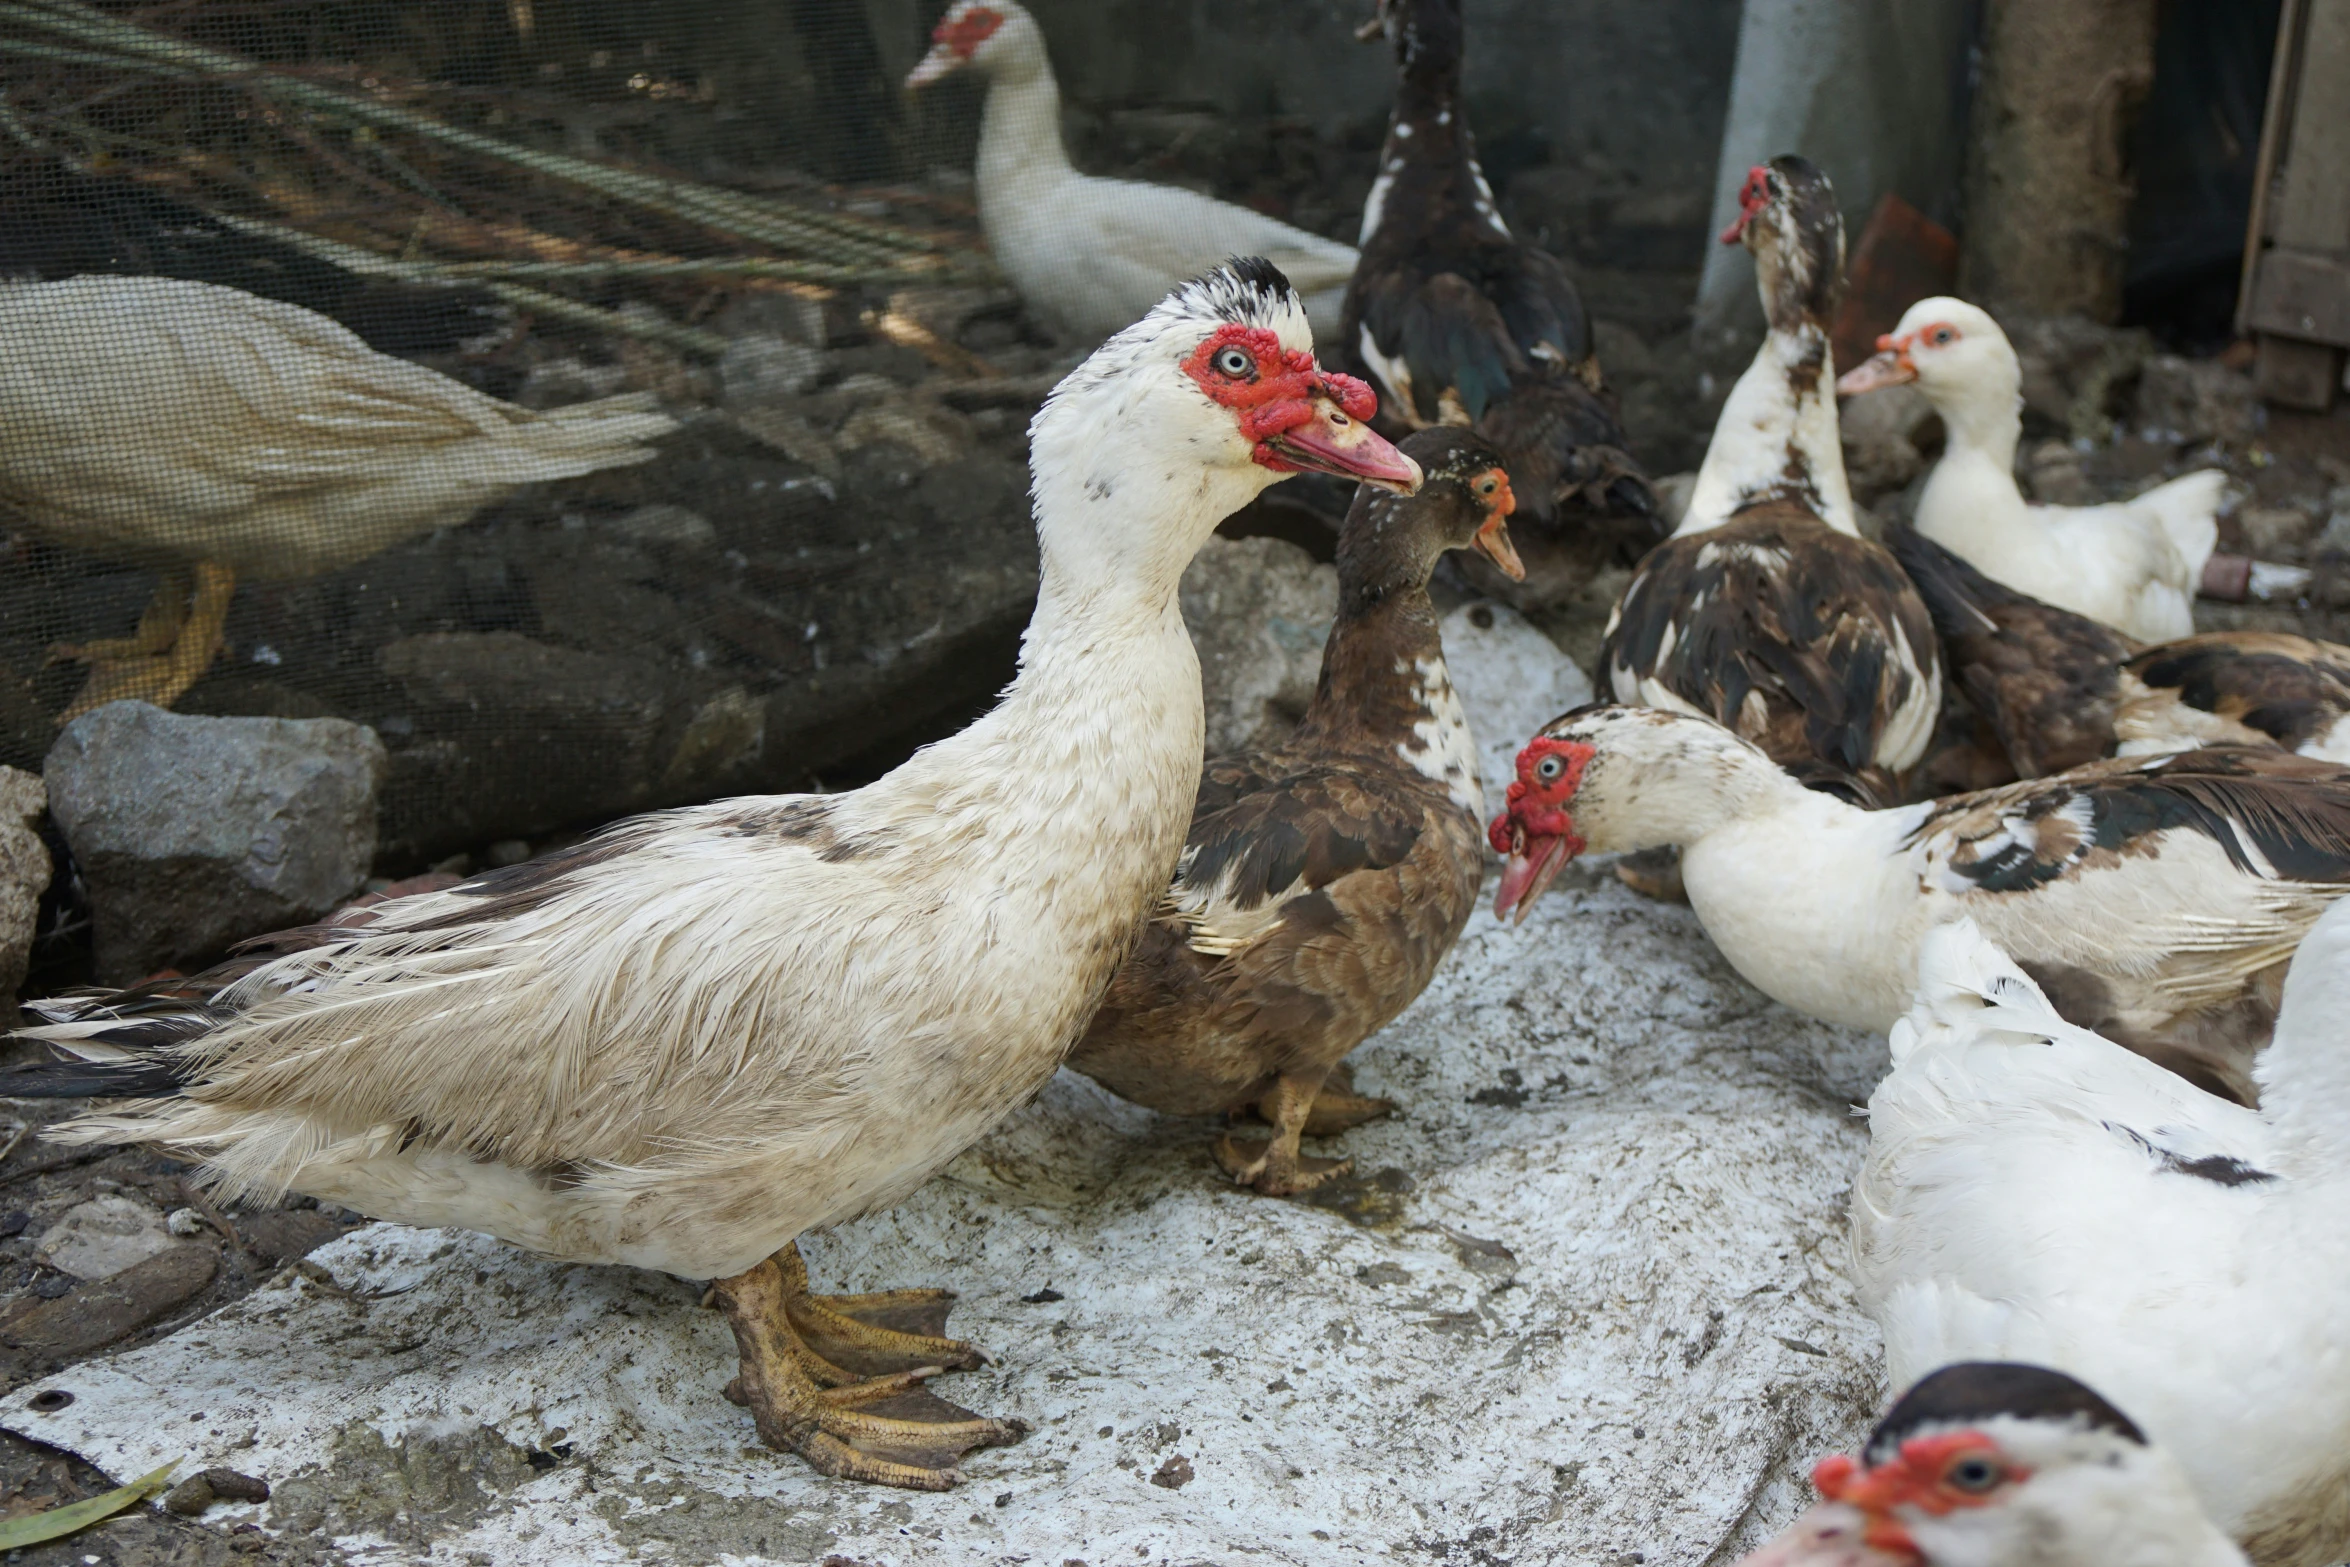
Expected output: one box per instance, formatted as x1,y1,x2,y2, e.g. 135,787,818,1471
1485,702,1767,921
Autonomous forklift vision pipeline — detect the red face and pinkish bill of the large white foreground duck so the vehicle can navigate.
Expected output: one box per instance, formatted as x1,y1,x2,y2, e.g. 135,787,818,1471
1182,324,1419,493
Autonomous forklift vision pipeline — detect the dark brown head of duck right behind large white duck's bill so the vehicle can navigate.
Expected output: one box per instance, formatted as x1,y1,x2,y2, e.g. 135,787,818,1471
1337,425,1525,601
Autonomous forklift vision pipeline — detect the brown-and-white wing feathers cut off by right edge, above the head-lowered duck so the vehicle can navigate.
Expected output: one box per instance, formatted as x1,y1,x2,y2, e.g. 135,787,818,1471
2115,632,2350,761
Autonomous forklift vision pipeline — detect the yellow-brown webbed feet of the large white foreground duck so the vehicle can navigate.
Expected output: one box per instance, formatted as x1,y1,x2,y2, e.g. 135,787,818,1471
712,1243,1027,1492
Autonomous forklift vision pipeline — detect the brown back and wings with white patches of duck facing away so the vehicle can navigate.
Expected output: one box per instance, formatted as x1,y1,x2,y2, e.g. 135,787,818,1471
1600,500,1941,803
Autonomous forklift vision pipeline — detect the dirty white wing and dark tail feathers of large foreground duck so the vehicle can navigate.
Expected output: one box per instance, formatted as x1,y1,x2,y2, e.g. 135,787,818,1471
9,796,897,1193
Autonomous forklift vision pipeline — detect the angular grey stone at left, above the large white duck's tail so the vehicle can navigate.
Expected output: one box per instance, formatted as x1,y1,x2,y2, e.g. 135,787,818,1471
42,702,385,984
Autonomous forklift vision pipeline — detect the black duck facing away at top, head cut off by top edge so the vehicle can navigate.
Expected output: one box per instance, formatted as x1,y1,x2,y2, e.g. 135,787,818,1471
1337,0,1664,608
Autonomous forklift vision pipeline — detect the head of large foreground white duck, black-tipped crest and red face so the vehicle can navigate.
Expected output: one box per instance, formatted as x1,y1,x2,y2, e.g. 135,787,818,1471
1029,256,1419,576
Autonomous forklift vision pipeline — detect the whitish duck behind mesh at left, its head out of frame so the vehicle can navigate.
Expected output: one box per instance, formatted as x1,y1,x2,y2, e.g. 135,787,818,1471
0,275,677,724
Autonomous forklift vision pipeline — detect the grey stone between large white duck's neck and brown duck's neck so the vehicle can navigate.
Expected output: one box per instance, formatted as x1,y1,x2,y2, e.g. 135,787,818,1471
1180,538,1337,756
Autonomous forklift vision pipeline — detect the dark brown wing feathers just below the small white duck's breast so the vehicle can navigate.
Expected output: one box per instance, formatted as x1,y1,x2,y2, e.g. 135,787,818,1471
1885,529,2136,778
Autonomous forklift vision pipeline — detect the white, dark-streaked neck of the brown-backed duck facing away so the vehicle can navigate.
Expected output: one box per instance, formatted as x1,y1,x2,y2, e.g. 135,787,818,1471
1678,320,1861,536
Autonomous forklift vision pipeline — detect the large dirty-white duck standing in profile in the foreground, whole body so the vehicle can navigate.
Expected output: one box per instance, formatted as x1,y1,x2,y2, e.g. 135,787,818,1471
7,258,1419,1489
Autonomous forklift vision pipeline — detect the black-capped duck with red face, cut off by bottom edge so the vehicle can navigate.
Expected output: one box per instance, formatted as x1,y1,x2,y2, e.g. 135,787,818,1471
1739,1360,2247,1567
